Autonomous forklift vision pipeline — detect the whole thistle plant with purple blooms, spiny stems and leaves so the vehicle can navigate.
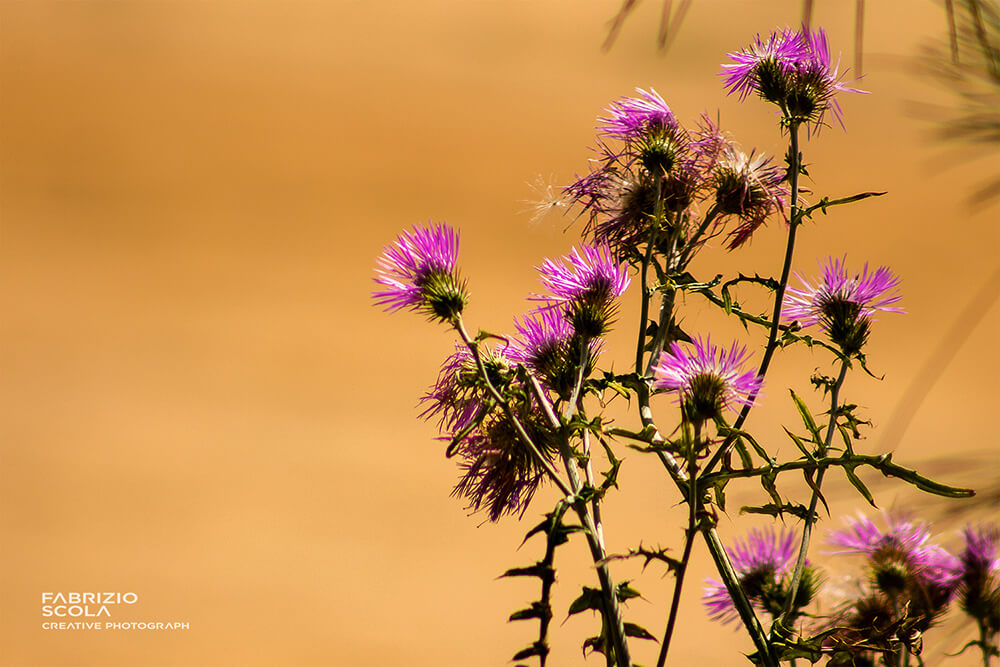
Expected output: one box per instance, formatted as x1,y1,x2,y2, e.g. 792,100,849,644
374,28,984,667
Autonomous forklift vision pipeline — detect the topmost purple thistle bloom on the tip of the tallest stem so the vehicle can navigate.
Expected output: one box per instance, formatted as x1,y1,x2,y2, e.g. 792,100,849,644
722,28,864,125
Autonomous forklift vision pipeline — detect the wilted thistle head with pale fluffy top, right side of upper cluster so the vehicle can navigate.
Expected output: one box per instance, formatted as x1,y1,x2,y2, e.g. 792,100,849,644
713,146,790,250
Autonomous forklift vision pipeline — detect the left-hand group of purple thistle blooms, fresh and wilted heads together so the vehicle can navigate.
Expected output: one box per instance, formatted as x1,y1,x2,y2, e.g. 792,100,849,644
375,224,630,521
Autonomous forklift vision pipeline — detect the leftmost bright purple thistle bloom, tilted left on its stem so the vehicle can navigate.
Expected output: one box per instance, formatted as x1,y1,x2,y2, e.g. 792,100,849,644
372,224,469,320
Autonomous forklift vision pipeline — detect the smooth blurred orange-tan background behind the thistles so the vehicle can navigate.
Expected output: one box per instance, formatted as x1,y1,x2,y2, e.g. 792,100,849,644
0,0,1000,666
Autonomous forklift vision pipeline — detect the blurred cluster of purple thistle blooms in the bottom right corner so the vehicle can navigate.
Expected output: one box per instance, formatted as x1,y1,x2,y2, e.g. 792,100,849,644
703,513,1000,665
